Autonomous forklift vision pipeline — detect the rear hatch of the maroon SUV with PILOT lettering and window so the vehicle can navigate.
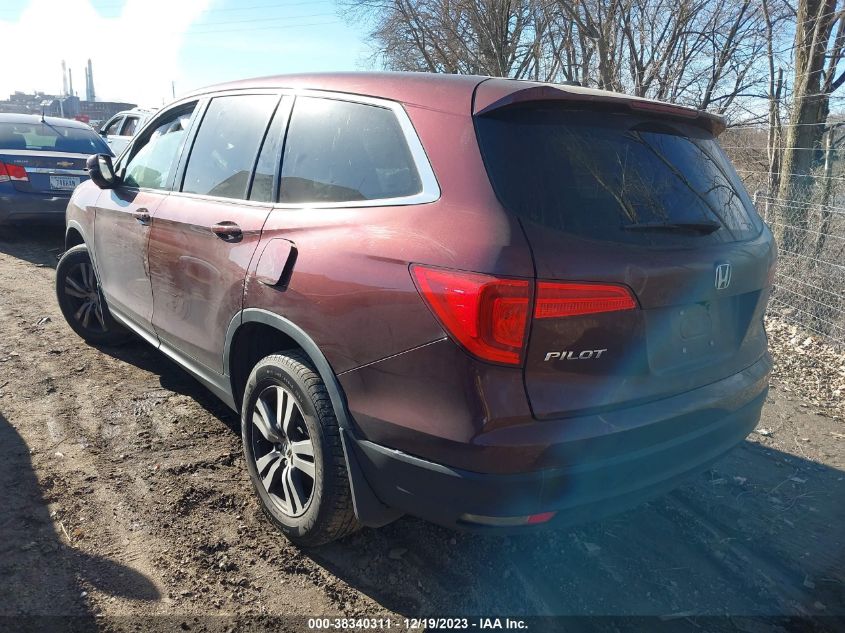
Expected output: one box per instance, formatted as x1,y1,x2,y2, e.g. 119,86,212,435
475,90,775,418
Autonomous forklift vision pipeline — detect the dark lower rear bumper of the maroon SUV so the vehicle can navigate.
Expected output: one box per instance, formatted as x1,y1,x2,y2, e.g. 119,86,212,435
346,357,771,530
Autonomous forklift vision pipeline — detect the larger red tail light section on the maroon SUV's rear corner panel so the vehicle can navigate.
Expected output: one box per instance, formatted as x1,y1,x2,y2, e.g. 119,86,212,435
411,265,531,365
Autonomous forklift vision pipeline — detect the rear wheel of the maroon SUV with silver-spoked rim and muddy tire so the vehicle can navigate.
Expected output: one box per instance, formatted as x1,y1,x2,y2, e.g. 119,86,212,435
241,352,358,547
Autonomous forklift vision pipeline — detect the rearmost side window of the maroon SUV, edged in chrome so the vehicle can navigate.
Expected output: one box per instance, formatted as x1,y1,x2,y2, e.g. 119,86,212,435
279,97,422,203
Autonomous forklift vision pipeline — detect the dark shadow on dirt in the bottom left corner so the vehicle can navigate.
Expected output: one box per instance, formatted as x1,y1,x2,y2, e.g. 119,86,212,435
0,414,159,631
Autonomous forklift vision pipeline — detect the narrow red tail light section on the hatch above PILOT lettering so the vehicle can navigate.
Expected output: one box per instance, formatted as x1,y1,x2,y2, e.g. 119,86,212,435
534,281,637,319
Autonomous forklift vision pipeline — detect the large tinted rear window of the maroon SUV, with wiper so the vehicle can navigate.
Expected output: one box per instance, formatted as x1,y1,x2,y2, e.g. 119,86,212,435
476,105,761,243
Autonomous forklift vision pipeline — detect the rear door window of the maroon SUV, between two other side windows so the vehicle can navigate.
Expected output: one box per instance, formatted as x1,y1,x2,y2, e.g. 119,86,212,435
182,95,279,198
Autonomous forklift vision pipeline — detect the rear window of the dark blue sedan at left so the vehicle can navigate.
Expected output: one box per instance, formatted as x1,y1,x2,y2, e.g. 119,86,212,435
0,123,111,154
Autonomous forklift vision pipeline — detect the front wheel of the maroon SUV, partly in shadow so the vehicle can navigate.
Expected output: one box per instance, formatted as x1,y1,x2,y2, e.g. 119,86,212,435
56,244,131,346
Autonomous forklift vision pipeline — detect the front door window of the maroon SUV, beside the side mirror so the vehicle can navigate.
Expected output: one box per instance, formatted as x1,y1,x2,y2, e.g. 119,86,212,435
123,103,196,189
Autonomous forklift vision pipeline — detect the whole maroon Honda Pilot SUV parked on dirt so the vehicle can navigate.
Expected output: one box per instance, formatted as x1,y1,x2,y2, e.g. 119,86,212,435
56,73,775,545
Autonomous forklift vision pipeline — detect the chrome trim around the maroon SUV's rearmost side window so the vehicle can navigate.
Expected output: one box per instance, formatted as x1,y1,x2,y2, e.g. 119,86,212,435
273,89,441,209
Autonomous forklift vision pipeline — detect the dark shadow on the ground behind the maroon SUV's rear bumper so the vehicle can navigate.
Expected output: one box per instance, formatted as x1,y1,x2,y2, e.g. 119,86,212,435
310,441,845,618
